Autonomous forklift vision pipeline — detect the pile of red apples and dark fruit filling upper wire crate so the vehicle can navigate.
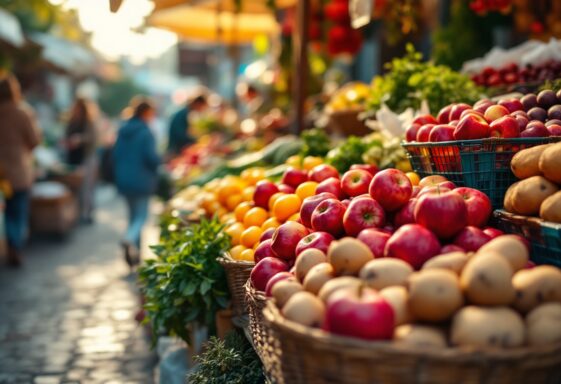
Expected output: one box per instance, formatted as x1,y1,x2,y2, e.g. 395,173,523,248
405,90,561,142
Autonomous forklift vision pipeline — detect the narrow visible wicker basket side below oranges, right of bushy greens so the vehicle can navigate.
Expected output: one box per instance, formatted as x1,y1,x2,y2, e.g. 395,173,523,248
218,253,255,318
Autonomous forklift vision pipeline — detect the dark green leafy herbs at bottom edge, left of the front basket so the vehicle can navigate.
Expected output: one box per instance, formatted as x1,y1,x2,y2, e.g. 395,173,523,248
187,332,265,384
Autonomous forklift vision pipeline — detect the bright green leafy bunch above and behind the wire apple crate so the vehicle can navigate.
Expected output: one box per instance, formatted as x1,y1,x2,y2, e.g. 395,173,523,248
368,44,480,113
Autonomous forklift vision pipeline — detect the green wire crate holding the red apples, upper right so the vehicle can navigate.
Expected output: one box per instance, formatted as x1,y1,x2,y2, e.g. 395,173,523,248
401,137,561,208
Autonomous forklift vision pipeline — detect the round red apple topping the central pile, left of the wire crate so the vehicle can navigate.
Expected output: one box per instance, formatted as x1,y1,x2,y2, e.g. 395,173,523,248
369,168,413,211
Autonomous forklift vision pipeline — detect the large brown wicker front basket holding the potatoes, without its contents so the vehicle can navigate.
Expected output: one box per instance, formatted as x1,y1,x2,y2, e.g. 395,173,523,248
264,303,561,384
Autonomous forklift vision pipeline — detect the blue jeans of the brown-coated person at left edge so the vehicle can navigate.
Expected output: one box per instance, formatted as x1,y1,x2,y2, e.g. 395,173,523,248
5,191,30,251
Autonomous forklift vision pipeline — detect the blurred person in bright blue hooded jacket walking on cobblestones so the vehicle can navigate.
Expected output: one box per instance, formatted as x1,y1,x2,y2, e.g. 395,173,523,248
113,97,160,268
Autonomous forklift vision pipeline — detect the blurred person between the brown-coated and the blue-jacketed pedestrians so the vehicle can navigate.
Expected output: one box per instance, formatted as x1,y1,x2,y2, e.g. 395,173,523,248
65,98,97,224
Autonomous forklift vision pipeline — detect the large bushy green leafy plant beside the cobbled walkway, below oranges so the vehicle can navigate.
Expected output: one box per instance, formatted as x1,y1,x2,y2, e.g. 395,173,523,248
139,218,231,341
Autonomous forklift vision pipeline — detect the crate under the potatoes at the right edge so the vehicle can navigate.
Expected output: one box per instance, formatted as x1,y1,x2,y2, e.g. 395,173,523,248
494,209,561,268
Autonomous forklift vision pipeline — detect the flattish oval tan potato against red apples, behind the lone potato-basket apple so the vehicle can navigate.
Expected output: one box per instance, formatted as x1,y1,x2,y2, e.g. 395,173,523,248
358,257,413,290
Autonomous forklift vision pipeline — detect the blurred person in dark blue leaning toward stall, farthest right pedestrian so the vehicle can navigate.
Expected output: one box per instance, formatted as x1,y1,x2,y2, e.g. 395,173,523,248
167,92,208,156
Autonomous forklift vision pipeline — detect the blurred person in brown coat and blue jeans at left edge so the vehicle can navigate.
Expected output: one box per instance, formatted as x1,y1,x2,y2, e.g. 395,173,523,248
0,74,41,266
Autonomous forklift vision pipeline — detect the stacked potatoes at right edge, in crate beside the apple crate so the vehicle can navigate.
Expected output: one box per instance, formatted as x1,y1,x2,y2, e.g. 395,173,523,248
504,143,561,223
